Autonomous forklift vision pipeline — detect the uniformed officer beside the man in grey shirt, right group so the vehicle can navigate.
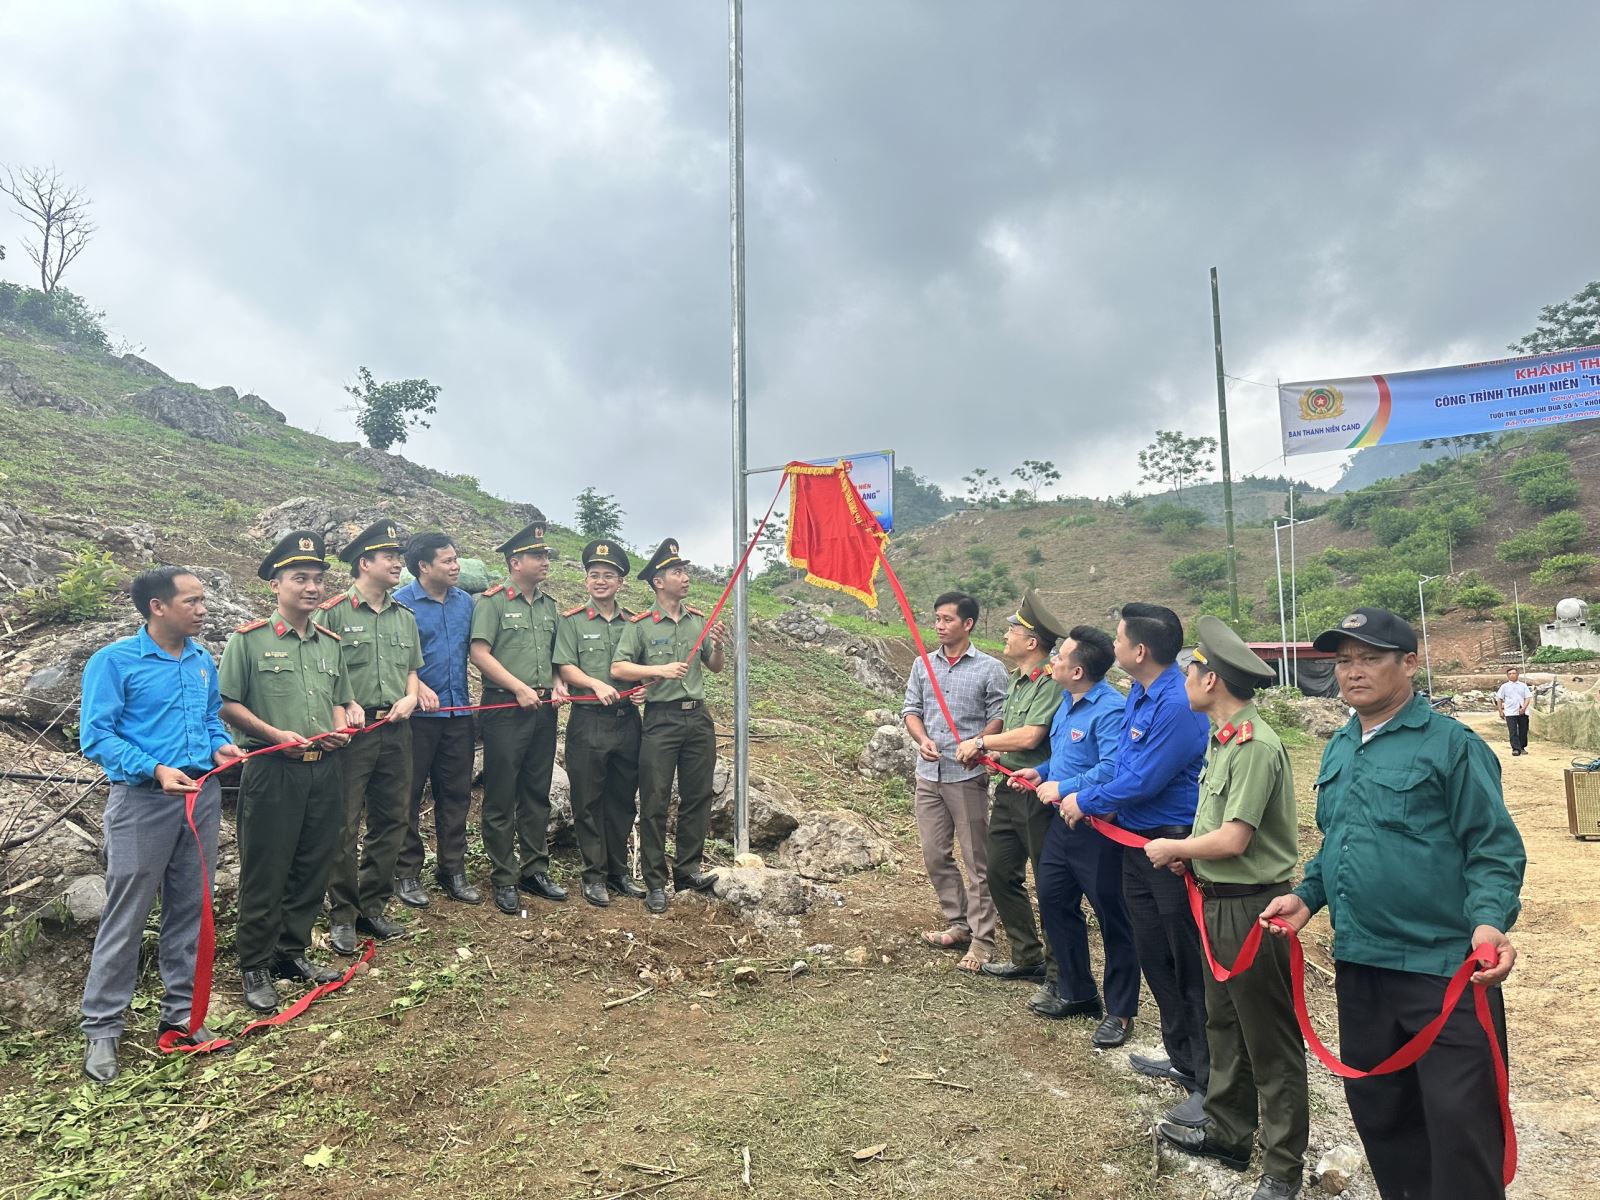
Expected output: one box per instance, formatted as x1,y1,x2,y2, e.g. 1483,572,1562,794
955,587,1061,1000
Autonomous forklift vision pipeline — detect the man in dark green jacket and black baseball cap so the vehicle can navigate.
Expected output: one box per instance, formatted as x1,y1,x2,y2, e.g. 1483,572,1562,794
1261,608,1526,1200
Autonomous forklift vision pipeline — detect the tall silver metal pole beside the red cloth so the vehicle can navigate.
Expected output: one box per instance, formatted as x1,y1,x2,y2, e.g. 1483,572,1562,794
728,0,750,854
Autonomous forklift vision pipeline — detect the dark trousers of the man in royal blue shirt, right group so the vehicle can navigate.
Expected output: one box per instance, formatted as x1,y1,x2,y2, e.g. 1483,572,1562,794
1122,846,1211,1091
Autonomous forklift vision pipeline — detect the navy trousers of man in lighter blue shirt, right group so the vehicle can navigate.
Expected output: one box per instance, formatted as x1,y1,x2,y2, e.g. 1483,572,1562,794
1036,810,1139,1016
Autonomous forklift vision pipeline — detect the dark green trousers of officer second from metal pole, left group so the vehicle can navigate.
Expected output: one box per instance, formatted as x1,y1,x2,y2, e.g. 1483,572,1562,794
566,701,640,883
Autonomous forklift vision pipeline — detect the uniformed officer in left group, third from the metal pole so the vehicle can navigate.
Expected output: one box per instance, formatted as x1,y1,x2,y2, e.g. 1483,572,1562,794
470,520,566,917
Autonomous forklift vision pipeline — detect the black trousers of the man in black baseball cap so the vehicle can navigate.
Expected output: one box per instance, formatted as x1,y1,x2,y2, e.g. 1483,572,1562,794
1334,963,1506,1200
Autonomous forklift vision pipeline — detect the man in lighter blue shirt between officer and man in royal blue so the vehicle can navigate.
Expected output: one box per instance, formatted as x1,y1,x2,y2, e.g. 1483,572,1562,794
1019,626,1139,1050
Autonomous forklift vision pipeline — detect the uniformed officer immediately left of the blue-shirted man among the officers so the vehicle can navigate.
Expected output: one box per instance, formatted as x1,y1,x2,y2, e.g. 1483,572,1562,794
322,518,422,954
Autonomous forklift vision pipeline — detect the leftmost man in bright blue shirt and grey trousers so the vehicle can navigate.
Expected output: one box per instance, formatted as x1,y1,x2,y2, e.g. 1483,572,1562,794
78,566,243,1083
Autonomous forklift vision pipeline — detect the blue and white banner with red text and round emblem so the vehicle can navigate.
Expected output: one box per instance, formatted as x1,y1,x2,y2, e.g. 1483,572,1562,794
1278,346,1600,454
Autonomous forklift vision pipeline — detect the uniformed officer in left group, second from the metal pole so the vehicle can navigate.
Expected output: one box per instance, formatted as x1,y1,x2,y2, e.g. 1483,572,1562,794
555,541,645,909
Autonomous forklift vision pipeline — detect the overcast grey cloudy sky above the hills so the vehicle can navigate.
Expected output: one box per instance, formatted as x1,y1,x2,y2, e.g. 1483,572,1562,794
0,0,1600,562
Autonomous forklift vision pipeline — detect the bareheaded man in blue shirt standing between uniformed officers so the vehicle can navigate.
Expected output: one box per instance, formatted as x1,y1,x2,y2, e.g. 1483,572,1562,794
395,533,483,909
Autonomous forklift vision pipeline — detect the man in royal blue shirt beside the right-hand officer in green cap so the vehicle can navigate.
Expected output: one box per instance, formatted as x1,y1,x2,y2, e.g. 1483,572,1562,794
1061,603,1211,1126
